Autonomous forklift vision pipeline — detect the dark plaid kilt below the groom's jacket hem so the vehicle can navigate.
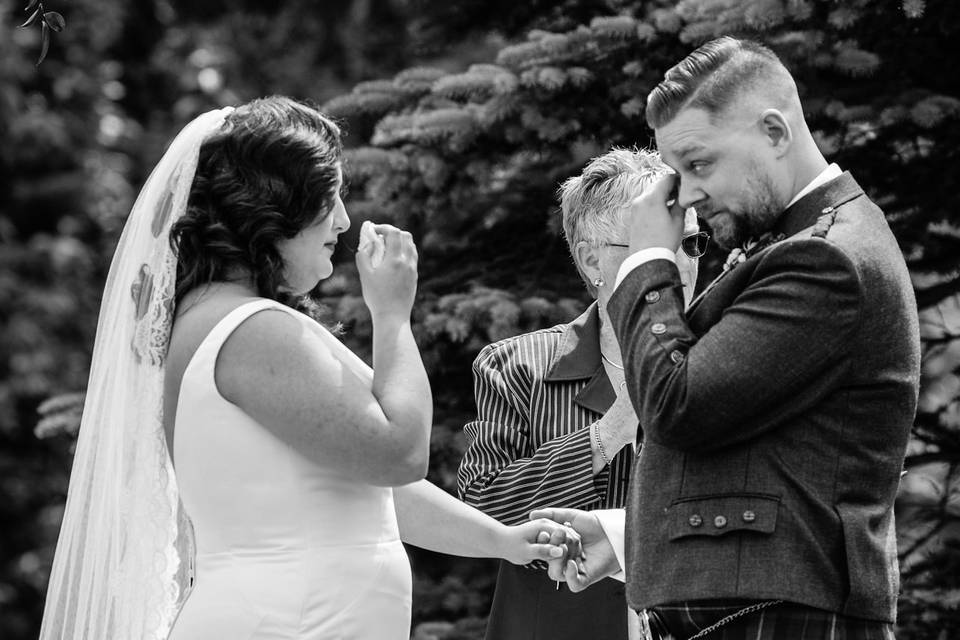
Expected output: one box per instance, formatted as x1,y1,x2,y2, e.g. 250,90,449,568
648,599,894,640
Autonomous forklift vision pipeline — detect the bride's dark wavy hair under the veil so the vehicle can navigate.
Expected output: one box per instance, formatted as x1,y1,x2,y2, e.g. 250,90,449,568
170,96,343,315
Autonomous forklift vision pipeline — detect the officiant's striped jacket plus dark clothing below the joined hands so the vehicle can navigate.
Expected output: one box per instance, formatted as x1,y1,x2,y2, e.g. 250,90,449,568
458,304,633,640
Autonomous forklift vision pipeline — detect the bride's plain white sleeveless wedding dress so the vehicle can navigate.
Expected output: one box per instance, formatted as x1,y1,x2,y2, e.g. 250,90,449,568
169,300,412,640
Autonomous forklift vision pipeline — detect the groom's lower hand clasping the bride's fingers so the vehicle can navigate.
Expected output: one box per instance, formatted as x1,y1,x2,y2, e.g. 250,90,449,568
530,509,620,593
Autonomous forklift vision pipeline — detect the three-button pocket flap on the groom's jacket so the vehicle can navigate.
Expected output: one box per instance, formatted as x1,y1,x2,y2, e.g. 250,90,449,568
667,493,780,540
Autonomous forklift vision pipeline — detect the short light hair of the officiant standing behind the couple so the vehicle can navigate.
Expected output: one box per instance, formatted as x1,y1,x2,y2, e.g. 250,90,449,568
557,147,670,294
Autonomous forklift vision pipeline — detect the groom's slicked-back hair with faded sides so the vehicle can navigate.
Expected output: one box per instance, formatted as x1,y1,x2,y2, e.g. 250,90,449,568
646,36,797,129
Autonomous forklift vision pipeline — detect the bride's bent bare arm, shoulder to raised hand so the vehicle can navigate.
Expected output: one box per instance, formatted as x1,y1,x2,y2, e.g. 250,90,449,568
215,225,433,486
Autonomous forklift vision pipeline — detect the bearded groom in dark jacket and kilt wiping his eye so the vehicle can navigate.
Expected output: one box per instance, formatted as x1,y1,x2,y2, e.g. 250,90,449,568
535,38,919,639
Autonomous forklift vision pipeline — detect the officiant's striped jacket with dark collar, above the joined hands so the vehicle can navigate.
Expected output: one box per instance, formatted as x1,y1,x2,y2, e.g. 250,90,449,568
457,303,634,524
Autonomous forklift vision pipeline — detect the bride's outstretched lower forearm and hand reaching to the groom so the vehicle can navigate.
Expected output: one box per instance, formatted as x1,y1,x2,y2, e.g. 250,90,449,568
393,480,579,564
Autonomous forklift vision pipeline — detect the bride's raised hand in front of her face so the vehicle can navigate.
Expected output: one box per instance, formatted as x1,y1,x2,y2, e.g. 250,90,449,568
357,224,417,318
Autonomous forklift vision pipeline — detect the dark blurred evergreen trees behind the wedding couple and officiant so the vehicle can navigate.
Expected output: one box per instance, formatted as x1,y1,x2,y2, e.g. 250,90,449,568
0,0,960,640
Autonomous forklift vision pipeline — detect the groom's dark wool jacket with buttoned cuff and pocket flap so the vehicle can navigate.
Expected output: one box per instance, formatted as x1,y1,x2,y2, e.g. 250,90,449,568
609,173,920,621
